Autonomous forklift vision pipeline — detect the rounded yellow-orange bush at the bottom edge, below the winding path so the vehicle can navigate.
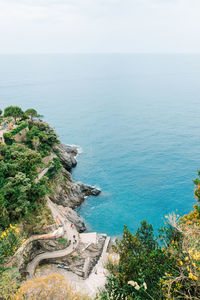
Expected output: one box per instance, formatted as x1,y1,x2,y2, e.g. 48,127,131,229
13,273,89,300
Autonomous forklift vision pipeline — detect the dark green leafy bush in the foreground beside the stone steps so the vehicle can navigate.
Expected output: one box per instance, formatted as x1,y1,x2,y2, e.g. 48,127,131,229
101,221,176,300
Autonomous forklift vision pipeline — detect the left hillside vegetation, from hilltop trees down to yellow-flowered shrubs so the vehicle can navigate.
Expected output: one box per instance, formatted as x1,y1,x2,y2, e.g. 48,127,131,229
0,106,61,299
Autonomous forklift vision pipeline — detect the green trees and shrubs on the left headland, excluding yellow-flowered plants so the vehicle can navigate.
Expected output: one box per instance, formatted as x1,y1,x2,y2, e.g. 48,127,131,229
0,106,59,229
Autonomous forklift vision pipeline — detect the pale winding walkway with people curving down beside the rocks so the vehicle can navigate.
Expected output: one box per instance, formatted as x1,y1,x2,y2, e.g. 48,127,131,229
27,199,79,278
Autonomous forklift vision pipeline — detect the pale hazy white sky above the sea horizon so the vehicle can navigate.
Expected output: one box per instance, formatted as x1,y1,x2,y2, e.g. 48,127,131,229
0,0,200,53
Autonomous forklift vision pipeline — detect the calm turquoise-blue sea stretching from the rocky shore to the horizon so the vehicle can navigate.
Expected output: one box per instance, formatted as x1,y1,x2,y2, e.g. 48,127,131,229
0,55,200,236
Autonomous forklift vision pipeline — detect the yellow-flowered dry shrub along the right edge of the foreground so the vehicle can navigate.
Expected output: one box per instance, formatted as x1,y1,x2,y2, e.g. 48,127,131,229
161,210,200,299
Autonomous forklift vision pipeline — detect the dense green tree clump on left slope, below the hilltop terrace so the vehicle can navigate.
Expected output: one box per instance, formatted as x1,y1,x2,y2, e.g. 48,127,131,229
0,144,46,228
